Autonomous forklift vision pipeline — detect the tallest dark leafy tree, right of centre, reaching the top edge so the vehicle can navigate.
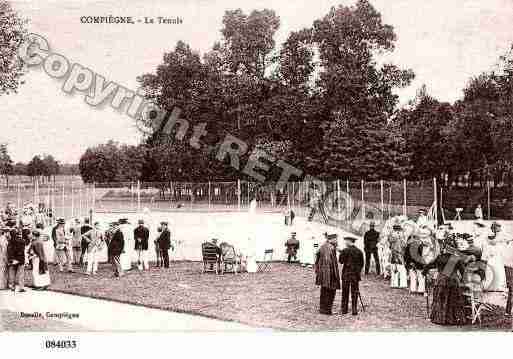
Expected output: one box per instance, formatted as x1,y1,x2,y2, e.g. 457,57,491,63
309,0,413,179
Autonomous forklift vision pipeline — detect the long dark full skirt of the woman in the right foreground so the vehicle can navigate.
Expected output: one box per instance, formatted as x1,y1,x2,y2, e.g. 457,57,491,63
431,273,467,325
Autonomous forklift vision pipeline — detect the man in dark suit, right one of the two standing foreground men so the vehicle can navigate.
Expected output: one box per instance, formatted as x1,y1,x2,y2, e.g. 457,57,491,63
339,237,363,315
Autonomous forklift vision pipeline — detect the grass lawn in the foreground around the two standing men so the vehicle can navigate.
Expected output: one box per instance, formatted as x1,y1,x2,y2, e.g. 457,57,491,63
35,262,511,331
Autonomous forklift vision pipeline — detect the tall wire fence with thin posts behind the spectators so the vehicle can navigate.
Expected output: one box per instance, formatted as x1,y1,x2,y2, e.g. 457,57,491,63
1,178,437,236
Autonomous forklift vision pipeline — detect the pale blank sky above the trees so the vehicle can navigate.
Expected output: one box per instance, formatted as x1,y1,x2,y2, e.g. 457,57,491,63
0,0,513,163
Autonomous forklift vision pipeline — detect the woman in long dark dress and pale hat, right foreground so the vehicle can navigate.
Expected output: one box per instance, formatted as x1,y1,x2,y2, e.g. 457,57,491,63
423,236,480,325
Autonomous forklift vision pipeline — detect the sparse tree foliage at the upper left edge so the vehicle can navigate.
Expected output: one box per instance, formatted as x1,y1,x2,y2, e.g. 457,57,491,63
0,0,26,96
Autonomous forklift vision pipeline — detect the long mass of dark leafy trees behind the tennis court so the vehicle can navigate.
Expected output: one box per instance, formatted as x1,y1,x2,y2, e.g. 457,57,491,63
80,0,513,191
